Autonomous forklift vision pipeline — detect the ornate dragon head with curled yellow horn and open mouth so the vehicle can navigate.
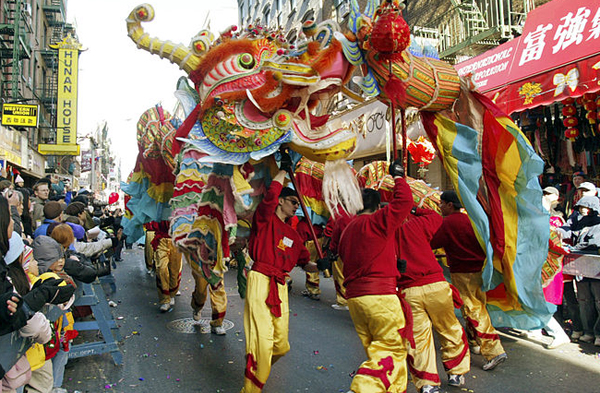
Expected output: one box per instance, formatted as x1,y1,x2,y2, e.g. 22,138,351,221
127,4,356,164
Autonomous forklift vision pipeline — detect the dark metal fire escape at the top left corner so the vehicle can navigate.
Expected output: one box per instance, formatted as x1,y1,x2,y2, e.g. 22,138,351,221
0,0,33,102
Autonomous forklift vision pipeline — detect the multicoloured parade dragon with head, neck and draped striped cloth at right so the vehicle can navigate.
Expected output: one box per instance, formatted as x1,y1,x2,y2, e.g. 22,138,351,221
127,0,553,328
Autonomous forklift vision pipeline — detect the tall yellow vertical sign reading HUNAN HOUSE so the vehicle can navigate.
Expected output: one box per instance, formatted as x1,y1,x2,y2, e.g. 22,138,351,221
51,35,81,145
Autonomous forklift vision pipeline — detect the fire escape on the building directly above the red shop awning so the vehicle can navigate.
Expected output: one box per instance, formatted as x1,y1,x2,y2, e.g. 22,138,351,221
409,0,534,63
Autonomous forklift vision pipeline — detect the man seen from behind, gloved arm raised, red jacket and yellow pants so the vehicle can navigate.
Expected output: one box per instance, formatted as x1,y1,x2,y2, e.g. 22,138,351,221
339,160,413,393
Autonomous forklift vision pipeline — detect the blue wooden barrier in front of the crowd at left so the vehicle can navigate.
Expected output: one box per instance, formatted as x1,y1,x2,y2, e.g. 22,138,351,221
69,274,123,365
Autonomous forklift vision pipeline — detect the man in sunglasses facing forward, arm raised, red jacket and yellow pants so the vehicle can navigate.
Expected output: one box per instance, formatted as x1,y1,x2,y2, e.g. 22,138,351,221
242,163,317,393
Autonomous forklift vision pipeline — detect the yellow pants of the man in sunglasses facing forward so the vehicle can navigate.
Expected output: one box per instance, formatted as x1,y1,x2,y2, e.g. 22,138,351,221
242,270,290,393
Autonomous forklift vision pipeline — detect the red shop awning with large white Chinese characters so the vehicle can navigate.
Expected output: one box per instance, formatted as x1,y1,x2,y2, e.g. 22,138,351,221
455,0,600,114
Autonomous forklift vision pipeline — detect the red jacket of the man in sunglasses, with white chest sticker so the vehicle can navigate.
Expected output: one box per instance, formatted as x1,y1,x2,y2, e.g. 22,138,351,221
248,182,310,273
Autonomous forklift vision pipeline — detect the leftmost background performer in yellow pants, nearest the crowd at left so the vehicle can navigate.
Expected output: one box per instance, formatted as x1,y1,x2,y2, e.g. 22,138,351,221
145,221,182,312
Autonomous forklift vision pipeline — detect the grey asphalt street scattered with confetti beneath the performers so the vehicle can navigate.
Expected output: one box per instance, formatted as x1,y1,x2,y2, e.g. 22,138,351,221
63,245,600,393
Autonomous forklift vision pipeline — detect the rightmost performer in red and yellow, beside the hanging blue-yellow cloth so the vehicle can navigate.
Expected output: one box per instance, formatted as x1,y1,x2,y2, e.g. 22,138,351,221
430,191,506,371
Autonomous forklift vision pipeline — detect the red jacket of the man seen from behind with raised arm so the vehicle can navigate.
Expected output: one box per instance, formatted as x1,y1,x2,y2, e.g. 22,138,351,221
338,178,413,298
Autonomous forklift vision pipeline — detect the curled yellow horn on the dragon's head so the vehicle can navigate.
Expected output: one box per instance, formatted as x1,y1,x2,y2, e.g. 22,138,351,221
126,4,210,75
